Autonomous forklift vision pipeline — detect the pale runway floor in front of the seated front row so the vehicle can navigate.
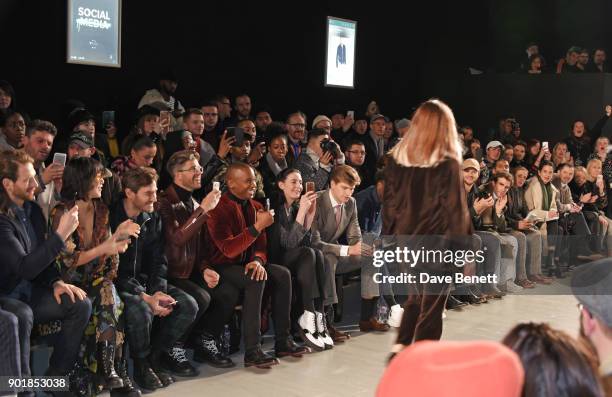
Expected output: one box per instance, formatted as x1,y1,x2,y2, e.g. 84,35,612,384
149,280,578,397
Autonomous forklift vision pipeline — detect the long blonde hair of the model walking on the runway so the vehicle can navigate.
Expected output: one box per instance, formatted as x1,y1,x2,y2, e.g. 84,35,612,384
390,99,462,167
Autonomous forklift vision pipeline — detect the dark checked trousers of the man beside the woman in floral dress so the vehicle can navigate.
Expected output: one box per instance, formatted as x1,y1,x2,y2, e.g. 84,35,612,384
119,284,198,358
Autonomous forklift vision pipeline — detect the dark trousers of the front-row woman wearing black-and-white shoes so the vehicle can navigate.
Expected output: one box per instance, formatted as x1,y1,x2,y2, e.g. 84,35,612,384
282,247,327,313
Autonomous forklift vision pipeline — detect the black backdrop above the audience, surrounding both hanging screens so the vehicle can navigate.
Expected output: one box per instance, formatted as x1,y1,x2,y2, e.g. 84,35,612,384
0,0,612,142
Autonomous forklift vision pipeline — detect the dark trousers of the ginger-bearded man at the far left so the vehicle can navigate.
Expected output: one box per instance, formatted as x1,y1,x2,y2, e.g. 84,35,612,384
30,287,91,375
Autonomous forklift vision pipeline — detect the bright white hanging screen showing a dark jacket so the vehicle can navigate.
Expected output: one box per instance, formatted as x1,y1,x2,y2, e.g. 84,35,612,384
325,17,357,88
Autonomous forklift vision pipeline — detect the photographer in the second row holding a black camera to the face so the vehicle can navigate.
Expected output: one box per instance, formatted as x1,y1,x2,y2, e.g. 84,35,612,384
294,129,344,191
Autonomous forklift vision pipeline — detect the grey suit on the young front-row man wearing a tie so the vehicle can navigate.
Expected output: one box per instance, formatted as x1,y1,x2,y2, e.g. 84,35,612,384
311,189,366,305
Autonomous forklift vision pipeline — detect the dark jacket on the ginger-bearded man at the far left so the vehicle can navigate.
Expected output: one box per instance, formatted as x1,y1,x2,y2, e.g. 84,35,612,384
0,201,64,295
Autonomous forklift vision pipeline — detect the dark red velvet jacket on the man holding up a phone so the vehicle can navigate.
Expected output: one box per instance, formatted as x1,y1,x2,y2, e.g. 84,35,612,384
206,192,268,267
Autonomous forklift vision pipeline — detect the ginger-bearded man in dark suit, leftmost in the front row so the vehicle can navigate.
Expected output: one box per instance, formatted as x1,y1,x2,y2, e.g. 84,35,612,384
0,152,91,392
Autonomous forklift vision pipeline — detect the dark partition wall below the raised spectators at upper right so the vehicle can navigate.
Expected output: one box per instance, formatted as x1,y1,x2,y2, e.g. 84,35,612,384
431,74,612,147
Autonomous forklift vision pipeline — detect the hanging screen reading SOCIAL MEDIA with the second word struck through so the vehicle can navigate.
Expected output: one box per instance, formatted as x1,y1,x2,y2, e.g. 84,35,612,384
66,0,121,68
